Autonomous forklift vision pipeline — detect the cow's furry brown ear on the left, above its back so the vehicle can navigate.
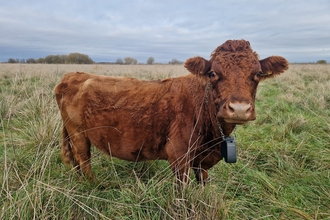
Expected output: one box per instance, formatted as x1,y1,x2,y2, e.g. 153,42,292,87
184,57,211,75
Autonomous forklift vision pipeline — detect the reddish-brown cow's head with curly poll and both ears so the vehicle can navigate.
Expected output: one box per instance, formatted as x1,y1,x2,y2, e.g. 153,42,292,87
185,40,288,124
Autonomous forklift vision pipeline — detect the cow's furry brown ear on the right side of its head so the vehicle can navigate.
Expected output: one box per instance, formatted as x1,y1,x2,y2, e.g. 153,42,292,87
259,56,289,80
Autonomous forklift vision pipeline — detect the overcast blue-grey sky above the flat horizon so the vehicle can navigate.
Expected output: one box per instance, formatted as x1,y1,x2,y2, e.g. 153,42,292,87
0,0,330,63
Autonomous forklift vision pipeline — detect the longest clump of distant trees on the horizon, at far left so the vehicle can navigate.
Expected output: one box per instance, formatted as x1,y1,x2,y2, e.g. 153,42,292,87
8,53,94,64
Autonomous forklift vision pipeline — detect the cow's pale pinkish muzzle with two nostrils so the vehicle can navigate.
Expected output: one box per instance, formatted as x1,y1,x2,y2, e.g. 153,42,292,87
217,101,256,124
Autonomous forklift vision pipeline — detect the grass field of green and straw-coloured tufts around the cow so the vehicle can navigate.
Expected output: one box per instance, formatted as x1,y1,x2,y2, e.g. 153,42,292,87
0,64,330,220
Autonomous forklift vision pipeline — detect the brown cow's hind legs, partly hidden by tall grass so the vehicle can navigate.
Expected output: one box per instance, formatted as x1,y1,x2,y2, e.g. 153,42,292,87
61,128,94,179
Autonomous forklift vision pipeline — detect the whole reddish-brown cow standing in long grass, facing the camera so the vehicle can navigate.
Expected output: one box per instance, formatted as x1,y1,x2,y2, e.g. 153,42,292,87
55,40,288,183
